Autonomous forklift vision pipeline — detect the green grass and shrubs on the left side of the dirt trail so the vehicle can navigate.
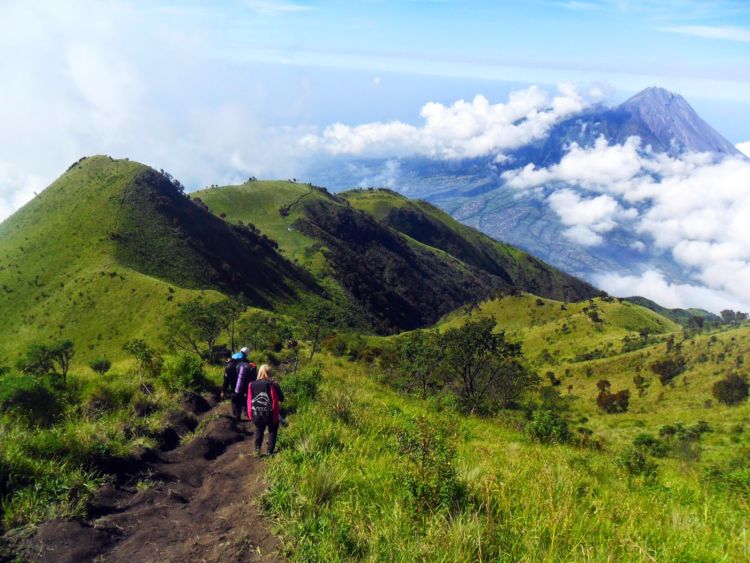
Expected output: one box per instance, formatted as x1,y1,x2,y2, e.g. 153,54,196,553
0,361,221,532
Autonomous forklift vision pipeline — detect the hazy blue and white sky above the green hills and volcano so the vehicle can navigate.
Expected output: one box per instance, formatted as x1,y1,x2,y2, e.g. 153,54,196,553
0,0,750,303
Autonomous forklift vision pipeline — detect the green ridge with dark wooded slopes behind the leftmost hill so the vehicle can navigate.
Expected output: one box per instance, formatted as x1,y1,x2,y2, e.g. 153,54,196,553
192,181,598,332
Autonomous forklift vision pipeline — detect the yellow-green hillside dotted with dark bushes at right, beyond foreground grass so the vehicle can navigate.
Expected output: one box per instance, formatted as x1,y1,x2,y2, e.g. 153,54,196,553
439,295,750,452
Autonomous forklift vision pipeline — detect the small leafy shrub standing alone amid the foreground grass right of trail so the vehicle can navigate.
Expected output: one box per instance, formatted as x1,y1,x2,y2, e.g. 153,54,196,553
398,417,467,513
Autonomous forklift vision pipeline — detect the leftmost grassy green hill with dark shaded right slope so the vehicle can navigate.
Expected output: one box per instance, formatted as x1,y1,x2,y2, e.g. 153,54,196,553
0,157,315,365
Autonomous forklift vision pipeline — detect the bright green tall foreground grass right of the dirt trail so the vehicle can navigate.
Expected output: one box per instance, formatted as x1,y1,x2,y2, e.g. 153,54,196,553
265,358,750,561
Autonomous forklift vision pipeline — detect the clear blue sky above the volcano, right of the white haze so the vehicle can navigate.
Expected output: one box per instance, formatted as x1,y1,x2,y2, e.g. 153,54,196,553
170,0,750,133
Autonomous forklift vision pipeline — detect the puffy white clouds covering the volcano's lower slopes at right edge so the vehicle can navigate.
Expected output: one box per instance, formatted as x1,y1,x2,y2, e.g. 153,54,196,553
503,137,750,308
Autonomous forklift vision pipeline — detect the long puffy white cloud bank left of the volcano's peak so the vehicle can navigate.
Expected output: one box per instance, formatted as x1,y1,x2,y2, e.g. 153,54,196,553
302,84,586,159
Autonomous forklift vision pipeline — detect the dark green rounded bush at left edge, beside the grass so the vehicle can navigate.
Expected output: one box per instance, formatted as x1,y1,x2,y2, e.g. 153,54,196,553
0,375,63,427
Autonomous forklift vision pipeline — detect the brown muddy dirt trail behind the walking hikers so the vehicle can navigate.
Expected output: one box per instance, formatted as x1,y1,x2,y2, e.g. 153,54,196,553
6,396,284,563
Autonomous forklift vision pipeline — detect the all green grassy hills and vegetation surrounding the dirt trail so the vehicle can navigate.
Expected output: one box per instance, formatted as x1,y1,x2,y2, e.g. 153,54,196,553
0,157,750,561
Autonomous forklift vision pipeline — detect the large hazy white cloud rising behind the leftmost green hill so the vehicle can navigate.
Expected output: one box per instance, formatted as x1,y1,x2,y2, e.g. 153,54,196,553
0,0,308,225
